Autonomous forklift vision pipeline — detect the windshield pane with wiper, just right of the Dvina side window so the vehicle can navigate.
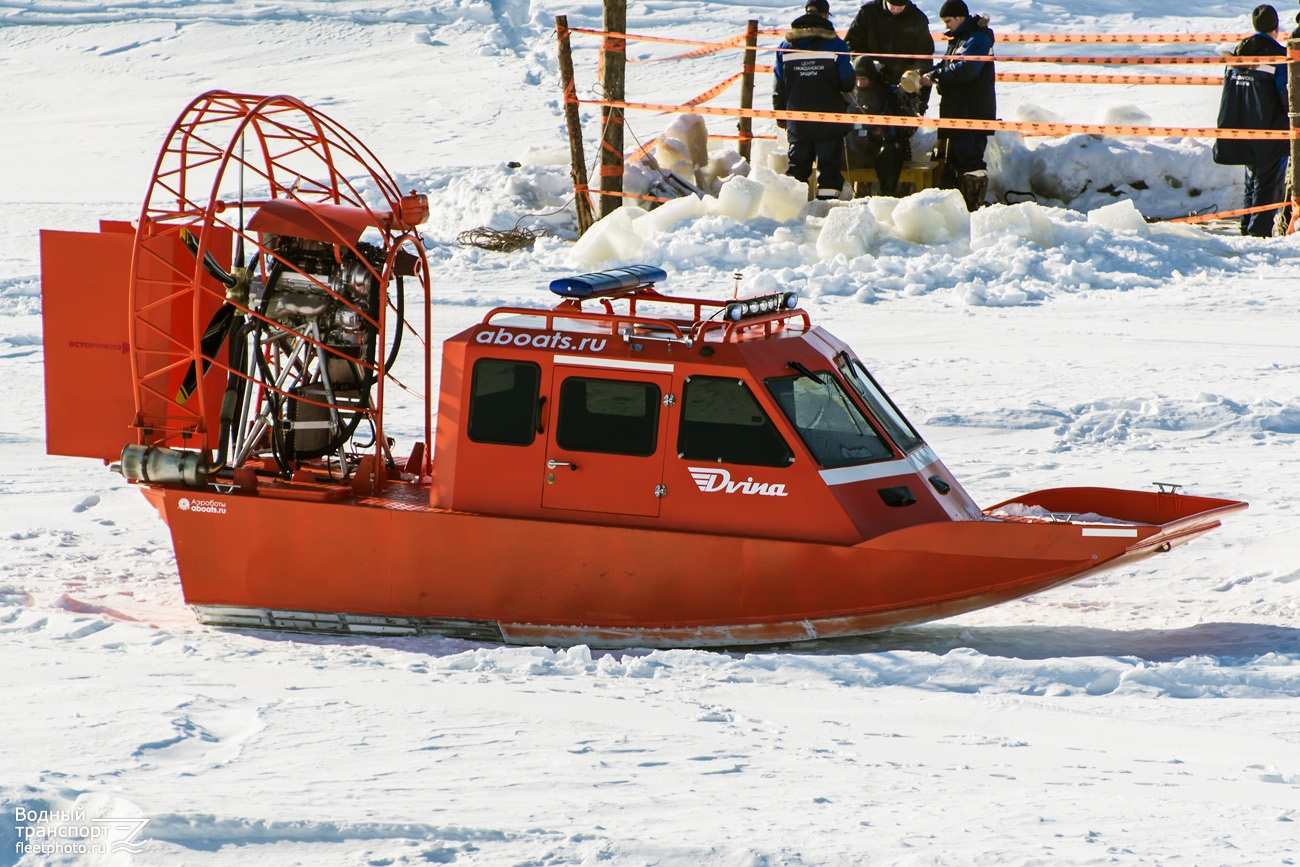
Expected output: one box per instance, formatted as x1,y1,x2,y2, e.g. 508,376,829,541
767,370,893,467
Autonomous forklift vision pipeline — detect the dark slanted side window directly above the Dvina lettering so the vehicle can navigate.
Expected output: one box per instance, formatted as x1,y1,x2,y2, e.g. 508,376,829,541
677,376,794,467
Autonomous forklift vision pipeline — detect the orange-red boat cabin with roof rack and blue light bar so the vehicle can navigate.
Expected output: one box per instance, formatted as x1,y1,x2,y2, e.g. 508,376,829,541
432,265,980,543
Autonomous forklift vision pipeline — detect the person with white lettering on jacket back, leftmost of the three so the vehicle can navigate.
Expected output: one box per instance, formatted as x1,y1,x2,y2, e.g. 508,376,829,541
772,0,854,199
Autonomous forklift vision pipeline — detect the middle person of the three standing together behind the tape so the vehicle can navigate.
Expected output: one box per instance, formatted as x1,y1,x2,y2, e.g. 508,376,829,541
844,0,935,196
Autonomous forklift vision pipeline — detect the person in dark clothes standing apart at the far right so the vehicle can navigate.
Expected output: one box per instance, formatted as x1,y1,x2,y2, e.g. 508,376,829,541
1214,5,1290,238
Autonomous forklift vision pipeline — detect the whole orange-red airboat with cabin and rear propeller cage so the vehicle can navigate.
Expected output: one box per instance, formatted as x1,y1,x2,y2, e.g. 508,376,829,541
42,92,1245,647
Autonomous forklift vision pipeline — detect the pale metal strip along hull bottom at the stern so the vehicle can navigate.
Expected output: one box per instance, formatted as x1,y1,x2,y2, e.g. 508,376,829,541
194,606,506,643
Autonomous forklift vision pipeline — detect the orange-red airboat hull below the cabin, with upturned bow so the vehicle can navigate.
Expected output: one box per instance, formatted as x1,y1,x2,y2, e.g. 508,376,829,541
146,487,1244,647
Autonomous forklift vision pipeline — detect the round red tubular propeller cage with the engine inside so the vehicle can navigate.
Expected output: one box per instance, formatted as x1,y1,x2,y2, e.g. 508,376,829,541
130,92,432,486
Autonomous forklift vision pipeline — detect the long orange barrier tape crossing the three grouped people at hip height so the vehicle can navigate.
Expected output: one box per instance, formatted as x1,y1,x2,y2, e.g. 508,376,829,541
579,99,1292,142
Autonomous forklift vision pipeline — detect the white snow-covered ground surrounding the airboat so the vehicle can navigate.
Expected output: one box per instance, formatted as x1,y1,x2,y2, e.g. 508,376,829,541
0,0,1300,867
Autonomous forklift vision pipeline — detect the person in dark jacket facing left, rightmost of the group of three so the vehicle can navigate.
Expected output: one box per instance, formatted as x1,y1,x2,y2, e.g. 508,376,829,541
920,0,997,211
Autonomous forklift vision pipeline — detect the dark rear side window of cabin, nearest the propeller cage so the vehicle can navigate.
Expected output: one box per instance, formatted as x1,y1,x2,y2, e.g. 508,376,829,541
469,359,542,446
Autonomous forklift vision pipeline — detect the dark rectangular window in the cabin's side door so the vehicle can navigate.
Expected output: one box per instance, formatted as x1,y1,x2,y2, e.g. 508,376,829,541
555,377,659,456
